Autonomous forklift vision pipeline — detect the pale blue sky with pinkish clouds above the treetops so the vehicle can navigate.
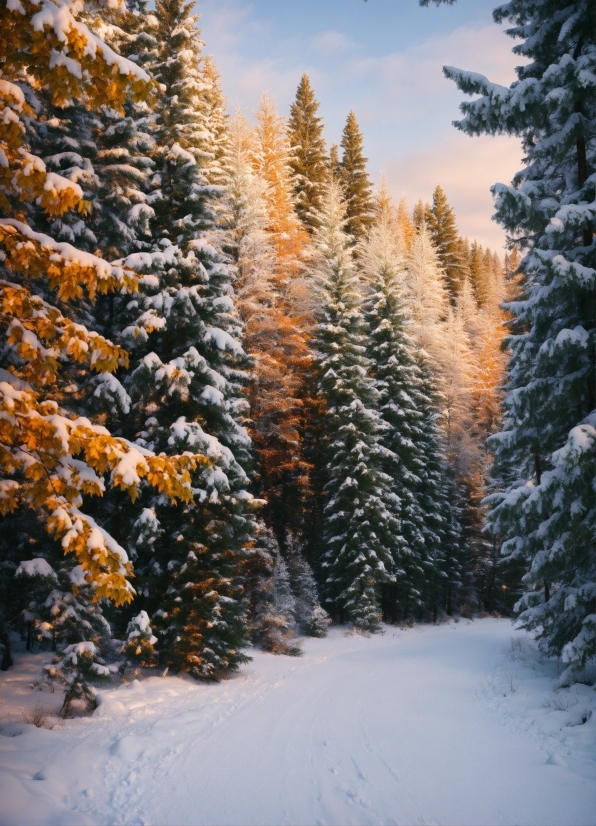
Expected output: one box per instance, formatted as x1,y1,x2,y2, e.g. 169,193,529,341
196,0,522,251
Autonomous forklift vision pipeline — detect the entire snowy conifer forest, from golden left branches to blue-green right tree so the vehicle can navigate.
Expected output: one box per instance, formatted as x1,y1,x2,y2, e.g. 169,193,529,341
0,0,596,823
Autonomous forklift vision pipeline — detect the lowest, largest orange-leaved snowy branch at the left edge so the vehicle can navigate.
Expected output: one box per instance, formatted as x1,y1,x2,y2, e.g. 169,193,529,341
0,376,200,603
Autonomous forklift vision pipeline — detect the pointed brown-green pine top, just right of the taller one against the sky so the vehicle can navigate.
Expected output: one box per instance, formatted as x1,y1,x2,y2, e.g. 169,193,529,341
340,112,374,240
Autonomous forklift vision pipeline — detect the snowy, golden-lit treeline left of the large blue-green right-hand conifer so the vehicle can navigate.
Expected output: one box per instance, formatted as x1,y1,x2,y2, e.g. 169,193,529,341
0,0,517,707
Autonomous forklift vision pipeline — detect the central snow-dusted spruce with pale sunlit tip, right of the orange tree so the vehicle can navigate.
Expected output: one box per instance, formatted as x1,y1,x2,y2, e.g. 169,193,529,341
315,182,398,631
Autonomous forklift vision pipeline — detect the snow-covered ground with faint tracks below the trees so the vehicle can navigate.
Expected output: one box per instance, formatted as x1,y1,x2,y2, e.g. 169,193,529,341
0,619,596,826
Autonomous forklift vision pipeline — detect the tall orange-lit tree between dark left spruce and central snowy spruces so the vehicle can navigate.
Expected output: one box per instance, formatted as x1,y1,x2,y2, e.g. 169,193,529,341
232,106,312,542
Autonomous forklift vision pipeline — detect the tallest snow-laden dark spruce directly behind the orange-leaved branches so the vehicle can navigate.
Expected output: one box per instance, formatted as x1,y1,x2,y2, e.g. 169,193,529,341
113,0,256,679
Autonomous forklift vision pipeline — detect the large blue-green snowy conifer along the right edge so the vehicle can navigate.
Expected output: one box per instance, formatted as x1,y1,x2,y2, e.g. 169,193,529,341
445,0,596,668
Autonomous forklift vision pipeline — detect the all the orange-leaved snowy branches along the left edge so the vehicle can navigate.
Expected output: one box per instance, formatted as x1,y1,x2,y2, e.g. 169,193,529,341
0,0,204,604
